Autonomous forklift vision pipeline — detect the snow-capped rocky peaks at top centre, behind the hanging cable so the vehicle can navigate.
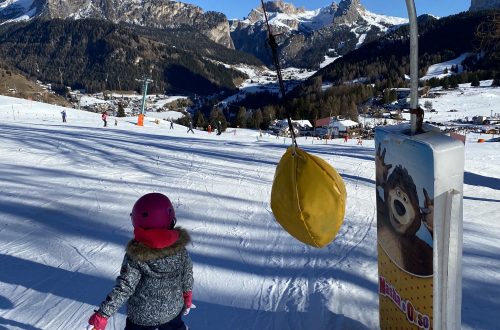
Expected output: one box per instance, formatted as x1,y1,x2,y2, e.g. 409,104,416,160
230,0,408,67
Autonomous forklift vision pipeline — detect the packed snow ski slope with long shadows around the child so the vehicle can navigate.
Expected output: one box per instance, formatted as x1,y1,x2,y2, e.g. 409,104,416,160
0,93,500,330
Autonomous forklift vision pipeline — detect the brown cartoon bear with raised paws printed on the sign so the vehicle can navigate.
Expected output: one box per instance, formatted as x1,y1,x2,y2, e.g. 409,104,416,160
376,146,433,276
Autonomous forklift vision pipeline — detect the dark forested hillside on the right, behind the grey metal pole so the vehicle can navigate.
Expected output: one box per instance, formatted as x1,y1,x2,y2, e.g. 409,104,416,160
260,11,500,124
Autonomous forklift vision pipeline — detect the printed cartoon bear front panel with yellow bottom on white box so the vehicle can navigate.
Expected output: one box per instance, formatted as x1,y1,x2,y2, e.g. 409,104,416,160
375,130,434,330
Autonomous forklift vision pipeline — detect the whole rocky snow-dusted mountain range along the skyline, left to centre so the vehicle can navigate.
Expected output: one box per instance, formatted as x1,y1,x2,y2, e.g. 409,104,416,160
0,0,407,68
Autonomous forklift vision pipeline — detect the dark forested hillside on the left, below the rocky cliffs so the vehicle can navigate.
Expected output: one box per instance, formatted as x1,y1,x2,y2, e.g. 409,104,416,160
0,19,260,95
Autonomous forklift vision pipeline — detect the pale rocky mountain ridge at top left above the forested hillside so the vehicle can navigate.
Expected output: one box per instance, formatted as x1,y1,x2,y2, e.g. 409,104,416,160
0,0,233,48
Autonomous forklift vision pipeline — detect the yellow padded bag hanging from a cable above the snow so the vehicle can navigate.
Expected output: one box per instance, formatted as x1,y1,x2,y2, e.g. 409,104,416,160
271,146,347,248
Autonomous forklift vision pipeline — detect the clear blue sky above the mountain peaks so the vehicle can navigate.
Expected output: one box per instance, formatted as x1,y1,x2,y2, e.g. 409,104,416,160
181,0,471,19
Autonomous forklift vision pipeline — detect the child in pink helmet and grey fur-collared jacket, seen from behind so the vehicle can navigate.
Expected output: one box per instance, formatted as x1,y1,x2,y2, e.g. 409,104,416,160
89,193,196,330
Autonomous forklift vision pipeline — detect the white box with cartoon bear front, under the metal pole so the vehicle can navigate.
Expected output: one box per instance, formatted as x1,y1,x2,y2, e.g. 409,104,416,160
375,125,464,330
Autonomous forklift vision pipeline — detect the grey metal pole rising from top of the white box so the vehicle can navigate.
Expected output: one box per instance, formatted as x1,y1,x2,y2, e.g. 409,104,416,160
406,0,421,135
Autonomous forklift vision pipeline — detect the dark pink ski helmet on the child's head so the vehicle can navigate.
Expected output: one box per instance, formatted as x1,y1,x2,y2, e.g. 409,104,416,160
130,193,176,229
